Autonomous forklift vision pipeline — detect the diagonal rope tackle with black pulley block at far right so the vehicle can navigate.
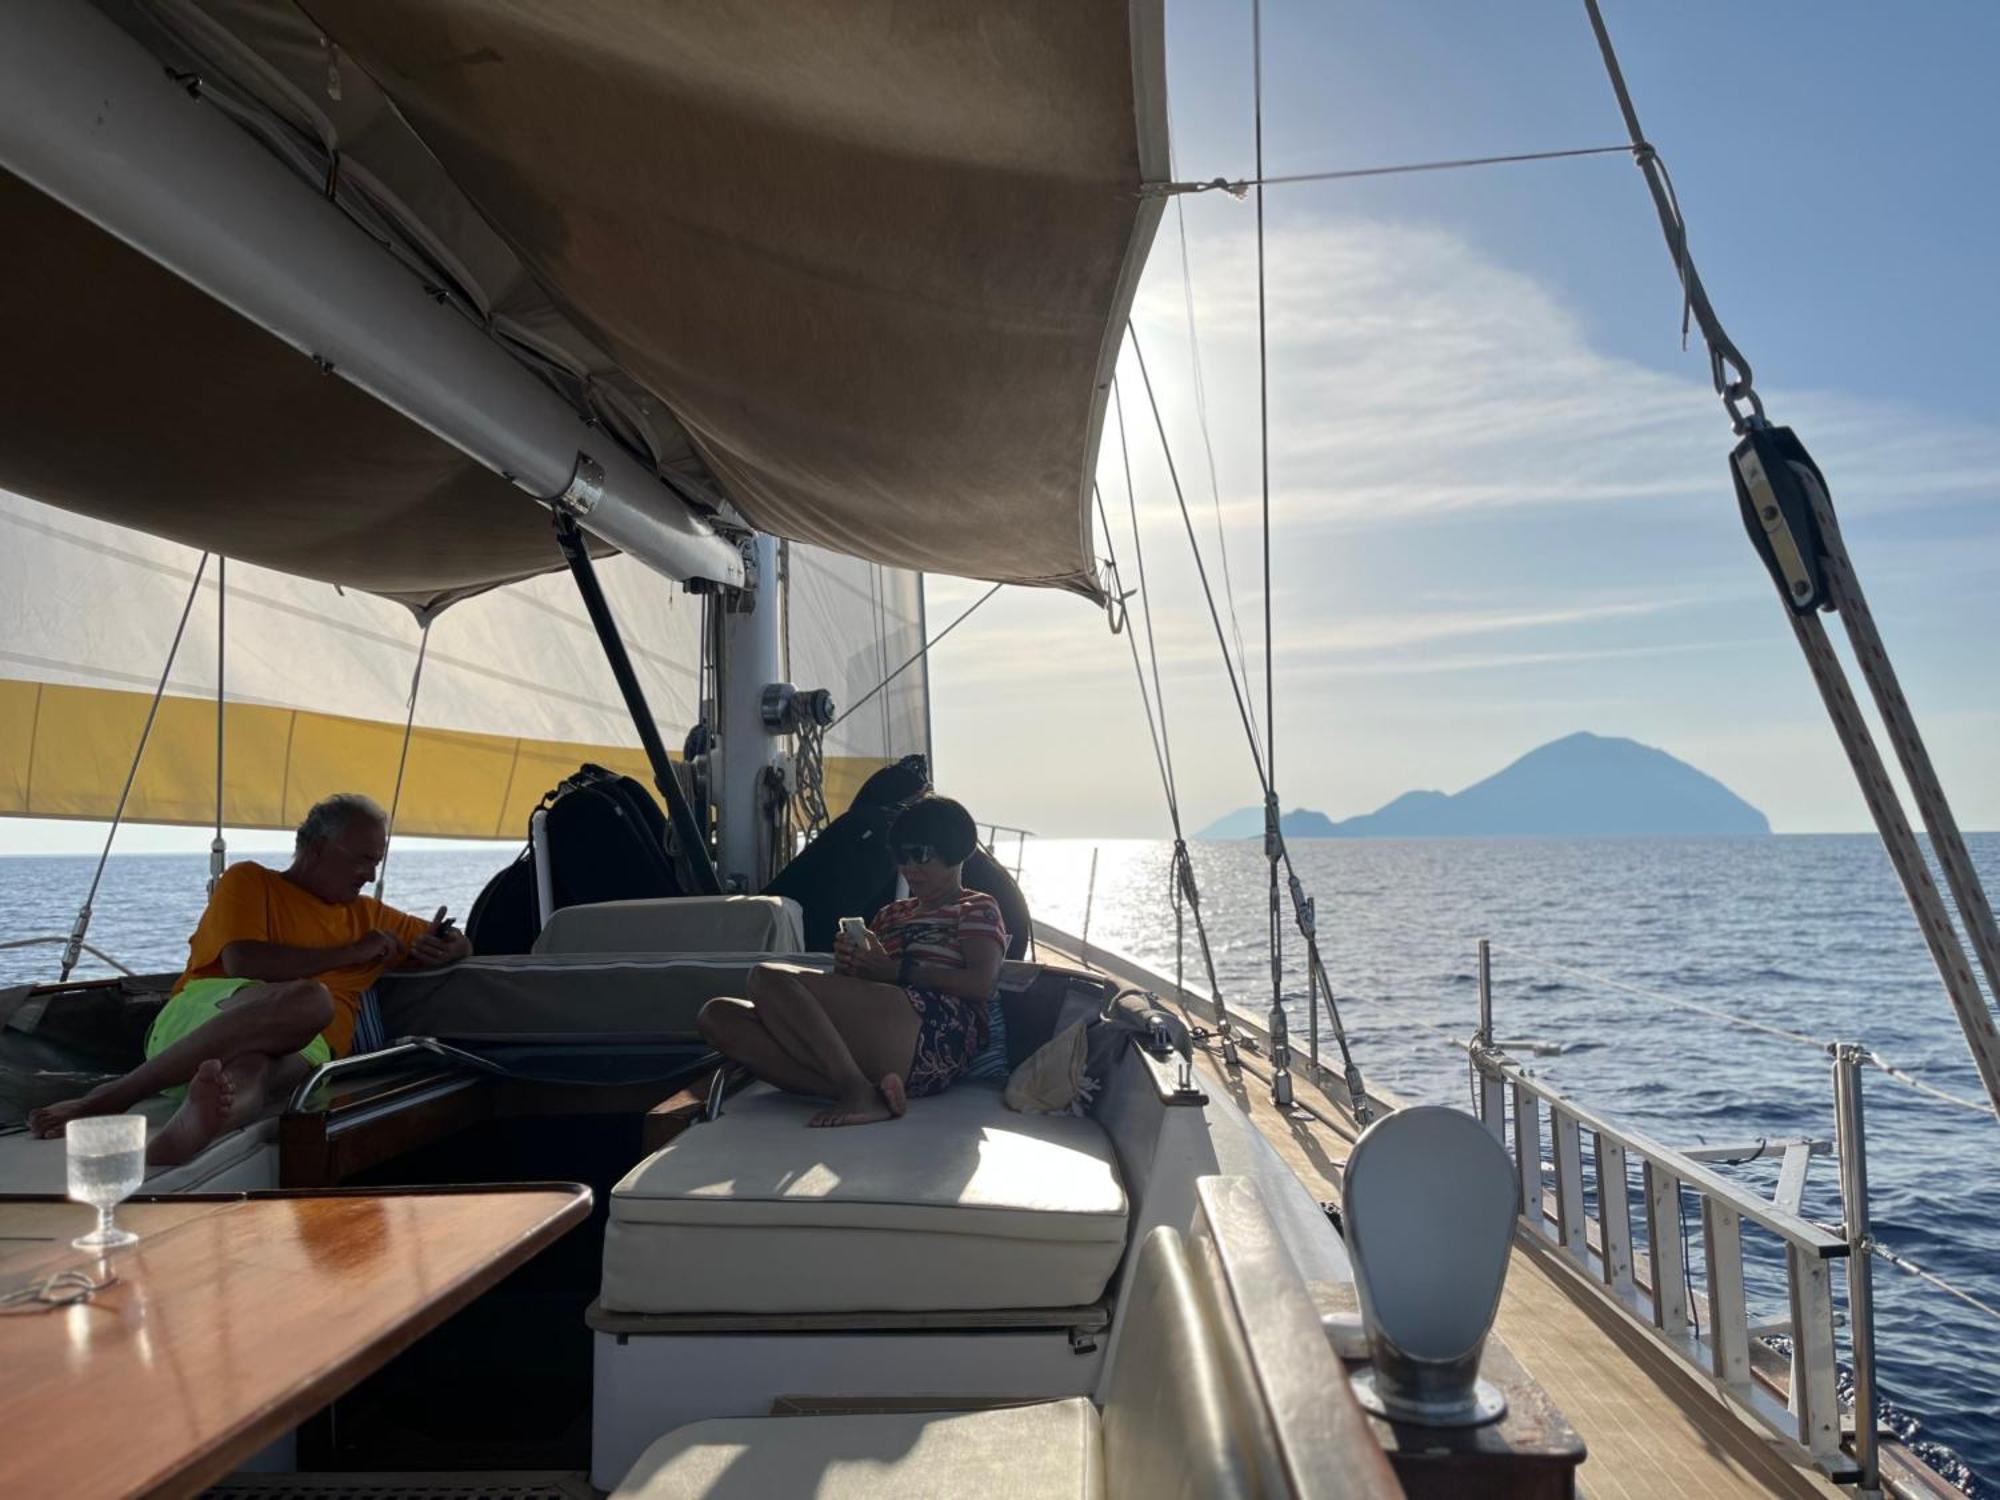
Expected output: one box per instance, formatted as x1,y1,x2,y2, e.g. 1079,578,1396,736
1584,0,2000,1114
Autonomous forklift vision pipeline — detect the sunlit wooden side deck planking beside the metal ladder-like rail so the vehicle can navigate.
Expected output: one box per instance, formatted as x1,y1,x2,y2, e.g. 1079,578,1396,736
1196,1054,1842,1500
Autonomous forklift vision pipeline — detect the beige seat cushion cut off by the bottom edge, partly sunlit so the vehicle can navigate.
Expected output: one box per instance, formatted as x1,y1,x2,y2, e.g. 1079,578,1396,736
612,1398,1104,1500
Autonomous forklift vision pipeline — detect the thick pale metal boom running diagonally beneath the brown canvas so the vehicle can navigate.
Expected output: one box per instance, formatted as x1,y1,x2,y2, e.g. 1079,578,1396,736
0,0,744,586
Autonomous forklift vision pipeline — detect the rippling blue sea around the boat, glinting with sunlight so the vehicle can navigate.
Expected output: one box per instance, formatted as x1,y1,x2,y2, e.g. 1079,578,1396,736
0,840,2000,1494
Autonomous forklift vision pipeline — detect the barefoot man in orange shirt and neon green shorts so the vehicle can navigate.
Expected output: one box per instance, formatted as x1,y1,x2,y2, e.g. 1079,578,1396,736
28,792,472,1166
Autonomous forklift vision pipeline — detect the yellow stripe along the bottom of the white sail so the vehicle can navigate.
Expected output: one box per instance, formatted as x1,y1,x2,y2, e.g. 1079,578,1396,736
0,680,888,838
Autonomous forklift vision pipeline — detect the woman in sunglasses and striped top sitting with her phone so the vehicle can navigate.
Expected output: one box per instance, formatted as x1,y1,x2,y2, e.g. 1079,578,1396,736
700,796,1006,1126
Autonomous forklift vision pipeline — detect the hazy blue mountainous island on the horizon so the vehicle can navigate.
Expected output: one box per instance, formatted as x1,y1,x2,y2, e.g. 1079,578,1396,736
1196,730,1770,838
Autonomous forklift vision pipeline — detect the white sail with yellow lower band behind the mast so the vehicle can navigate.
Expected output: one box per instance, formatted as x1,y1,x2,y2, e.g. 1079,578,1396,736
0,492,928,838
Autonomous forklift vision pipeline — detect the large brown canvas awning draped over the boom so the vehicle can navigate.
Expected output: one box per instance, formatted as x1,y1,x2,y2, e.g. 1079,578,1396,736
0,0,1166,602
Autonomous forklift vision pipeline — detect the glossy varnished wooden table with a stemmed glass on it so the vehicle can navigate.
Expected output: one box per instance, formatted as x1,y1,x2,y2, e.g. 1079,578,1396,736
0,1184,590,1500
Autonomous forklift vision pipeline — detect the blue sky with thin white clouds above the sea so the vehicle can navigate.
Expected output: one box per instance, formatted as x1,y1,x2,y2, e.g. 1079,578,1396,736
0,0,2000,850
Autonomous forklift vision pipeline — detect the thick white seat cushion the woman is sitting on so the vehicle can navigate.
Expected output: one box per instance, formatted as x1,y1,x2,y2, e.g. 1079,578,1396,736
598,1084,1126,1312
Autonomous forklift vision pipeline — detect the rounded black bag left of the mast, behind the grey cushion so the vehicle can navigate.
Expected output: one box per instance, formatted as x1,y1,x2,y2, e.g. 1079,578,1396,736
466,764,686,954
